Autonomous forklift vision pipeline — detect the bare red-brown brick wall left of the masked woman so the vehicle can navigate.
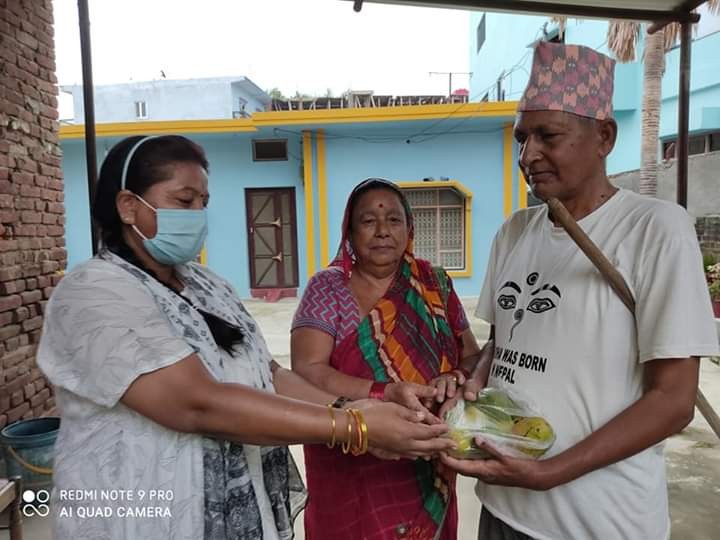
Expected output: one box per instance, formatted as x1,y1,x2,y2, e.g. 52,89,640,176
0,0,67,427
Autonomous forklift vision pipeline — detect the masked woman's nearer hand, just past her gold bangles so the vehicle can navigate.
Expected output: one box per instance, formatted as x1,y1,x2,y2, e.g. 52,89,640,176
348,399,455,459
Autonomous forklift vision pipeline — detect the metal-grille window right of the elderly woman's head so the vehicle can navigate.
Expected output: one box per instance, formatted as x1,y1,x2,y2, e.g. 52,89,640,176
403,187,467,270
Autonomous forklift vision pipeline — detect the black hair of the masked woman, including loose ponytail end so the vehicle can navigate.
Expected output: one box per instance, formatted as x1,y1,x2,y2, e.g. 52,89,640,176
92,135,244,353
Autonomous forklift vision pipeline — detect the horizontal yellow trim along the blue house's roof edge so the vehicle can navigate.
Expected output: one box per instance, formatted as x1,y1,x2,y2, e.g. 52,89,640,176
60,101,518,139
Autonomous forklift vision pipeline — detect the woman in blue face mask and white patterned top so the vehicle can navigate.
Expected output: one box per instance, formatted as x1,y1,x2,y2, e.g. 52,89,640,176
38,136,450,540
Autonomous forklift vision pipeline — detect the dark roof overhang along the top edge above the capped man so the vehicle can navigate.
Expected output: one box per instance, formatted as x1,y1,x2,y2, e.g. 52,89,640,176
347,0,703,22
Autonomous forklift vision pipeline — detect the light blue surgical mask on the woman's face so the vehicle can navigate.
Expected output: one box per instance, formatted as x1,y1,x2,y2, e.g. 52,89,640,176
133,195,208,265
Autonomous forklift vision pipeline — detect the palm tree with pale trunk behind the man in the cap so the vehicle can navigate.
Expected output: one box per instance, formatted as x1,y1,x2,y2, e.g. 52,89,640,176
553,0,720,197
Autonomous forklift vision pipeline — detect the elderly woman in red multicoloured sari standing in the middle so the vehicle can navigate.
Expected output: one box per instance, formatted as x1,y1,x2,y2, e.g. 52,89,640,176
291,178,479,540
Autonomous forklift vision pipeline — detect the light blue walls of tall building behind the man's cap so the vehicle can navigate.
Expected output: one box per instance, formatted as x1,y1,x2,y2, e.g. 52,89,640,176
469,12,720,174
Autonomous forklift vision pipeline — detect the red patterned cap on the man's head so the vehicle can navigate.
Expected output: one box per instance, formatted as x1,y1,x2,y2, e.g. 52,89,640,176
518,42,615,120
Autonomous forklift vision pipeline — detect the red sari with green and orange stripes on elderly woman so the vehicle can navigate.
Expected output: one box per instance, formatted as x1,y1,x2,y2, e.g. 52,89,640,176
305,178,464,540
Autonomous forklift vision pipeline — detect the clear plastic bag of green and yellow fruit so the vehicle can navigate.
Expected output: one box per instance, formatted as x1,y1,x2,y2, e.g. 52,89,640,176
445,387,555,459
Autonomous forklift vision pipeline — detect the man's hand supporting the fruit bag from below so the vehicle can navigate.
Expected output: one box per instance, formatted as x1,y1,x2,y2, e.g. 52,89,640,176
440,437,558,491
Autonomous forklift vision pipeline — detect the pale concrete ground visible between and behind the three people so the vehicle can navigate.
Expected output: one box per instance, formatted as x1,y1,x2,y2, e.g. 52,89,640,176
0,299,720,540
